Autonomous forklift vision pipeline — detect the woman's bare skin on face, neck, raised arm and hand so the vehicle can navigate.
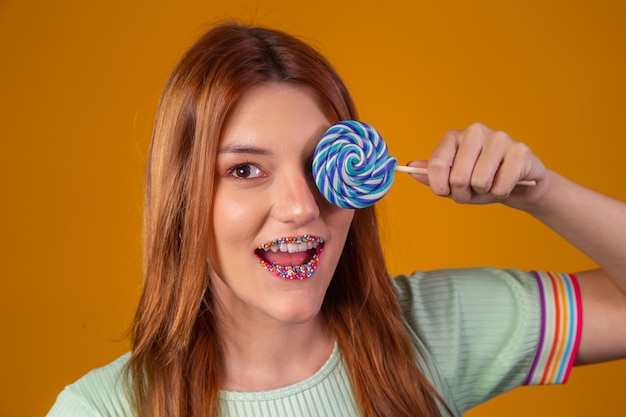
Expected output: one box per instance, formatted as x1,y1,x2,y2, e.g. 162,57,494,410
211,83,626,391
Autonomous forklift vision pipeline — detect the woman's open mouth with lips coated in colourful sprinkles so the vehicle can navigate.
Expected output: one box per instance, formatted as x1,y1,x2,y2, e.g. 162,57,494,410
254,235,324,280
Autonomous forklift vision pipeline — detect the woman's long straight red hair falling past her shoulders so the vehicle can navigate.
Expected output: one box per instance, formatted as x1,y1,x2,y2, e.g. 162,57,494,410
127,23,440,417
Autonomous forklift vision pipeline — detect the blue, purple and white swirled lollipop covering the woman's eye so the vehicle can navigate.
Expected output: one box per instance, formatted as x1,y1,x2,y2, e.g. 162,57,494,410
313,120,535,209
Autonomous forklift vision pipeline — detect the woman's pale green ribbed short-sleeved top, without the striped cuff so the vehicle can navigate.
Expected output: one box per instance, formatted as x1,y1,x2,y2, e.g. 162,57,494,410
48,268,575,417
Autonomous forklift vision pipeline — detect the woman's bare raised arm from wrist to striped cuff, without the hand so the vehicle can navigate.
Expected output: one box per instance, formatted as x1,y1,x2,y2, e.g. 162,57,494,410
522,171,626,364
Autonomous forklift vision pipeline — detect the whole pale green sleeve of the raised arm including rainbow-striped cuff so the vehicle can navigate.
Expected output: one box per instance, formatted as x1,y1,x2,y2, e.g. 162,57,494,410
393,268,581,411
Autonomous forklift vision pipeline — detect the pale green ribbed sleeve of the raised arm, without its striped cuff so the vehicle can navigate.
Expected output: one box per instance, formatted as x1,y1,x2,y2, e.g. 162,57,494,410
393,268,541,414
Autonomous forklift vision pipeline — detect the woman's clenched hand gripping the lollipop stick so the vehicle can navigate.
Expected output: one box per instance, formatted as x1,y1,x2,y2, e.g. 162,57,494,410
408,123,547,208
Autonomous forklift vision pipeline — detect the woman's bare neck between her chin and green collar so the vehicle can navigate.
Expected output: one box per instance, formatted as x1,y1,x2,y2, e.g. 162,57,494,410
220,308,335,391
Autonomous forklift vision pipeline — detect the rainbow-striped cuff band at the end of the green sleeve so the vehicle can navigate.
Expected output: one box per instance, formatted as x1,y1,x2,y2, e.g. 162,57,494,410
524,272,582,385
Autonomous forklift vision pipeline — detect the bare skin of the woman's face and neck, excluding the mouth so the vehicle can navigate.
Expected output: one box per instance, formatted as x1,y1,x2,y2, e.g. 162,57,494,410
211,83,354,391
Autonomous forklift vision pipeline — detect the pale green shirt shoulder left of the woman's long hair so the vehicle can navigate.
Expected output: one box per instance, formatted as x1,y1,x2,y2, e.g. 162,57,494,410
47,353,133,417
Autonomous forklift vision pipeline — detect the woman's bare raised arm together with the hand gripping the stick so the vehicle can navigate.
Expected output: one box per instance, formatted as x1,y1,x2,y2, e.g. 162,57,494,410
410,124,626,363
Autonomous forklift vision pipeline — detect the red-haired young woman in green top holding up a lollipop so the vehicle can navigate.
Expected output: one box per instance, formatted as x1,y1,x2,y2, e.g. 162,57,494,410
49,24,626,417
